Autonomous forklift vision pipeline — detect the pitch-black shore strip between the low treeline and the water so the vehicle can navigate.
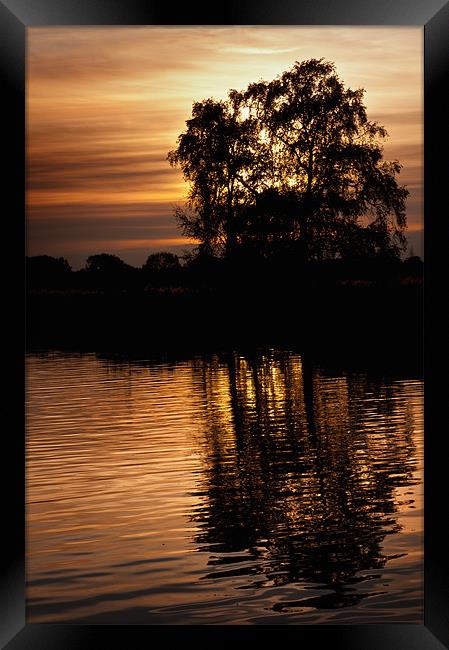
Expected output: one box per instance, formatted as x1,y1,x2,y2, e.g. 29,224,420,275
26,284,423,374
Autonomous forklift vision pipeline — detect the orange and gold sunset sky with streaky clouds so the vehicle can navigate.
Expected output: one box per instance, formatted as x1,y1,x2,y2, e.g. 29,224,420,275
27,26,423,269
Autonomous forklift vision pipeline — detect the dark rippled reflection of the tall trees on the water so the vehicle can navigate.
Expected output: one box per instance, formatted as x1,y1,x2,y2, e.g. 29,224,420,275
188,351,416,607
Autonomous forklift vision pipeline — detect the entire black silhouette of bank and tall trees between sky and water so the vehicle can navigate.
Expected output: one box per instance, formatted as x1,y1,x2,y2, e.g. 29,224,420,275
27,59,423,370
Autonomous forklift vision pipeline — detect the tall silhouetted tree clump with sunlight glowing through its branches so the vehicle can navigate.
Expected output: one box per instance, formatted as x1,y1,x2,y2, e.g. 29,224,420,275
168,59,408,260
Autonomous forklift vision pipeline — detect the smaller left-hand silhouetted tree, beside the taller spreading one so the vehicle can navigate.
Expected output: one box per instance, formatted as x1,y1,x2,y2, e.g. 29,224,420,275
168,95,257,255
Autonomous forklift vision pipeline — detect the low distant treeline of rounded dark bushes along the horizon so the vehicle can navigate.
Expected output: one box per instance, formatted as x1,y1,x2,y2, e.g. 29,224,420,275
26,251,424,290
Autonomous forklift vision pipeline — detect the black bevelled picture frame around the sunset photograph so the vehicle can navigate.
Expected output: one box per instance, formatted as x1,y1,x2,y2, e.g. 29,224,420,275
0,0,449,650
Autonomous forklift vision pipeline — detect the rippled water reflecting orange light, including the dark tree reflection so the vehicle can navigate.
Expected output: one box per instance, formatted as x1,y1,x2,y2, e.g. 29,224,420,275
26,350,423,624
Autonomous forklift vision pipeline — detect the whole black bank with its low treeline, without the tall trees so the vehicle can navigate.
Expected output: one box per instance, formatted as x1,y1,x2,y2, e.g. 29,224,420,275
27,253,423,373
